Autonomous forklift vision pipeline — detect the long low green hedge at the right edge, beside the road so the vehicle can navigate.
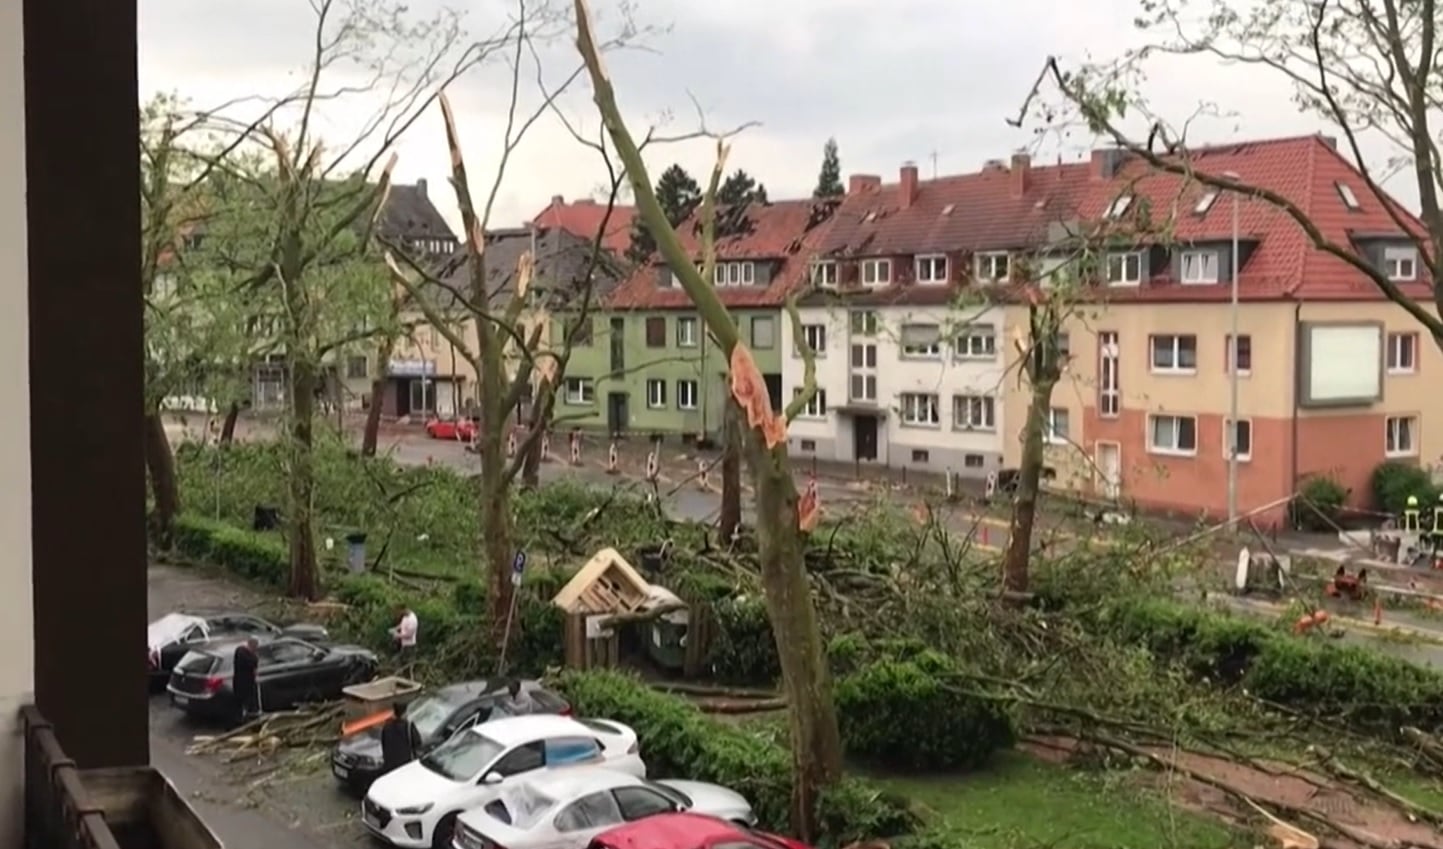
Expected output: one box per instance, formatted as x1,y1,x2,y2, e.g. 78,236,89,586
1104,601,1443,736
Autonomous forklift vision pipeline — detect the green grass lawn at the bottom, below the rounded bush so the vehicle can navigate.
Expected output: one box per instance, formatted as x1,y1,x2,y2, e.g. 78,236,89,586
880,752,1253,849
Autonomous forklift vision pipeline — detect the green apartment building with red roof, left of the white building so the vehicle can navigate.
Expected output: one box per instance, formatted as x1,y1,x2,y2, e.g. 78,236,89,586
557,199,837,436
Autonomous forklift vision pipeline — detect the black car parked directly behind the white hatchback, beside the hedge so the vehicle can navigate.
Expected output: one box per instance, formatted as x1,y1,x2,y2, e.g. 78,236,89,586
330,682,571,791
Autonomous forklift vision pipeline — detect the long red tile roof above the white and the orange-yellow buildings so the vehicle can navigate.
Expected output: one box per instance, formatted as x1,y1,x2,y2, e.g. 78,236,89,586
823,136,1430,303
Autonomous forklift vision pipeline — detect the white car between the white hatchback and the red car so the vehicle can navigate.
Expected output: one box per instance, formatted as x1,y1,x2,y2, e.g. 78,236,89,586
452,768,756,849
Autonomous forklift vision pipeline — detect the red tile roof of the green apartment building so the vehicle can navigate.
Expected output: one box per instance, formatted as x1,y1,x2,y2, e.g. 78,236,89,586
606,198,837,309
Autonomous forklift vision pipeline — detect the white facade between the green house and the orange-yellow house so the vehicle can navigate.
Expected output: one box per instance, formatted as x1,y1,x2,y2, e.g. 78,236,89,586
782,305,1009,478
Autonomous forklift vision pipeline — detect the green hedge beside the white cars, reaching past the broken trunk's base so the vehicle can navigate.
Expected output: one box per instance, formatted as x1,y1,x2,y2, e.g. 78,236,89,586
556,671,919,846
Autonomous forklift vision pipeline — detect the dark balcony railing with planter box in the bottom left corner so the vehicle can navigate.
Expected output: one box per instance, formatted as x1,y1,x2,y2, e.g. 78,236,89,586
20,706,222,849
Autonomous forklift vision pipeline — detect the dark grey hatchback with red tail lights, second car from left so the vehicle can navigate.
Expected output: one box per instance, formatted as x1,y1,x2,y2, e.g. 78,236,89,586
166,637,378,720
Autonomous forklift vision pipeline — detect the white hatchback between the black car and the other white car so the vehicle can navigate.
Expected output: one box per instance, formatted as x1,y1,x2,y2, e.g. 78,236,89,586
361,713,646,849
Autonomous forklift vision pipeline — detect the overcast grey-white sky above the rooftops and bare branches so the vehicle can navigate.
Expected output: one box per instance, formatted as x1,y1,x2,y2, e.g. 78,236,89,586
140,0,1416,233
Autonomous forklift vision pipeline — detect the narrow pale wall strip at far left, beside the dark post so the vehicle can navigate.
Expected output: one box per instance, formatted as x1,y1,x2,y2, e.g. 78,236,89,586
0,3,35,846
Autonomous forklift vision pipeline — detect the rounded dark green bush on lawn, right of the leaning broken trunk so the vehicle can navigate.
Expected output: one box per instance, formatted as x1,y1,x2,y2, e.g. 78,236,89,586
835,651,1017,771
